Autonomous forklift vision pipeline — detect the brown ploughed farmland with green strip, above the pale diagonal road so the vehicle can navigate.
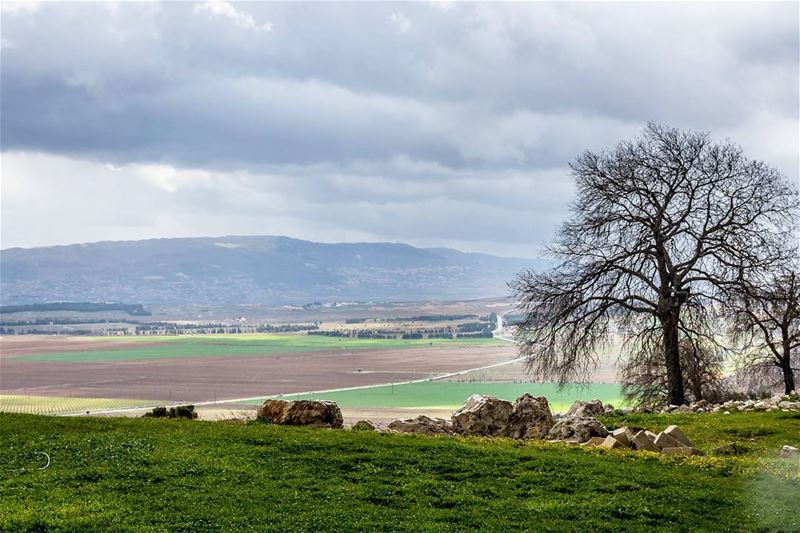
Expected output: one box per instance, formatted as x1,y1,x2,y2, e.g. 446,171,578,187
0,334,516,413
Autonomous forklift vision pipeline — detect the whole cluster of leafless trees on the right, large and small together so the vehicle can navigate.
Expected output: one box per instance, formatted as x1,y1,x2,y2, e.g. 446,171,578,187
511,124,800,405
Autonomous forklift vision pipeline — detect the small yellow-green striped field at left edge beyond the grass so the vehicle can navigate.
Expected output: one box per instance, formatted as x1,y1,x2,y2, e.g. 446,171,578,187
0,394,154,415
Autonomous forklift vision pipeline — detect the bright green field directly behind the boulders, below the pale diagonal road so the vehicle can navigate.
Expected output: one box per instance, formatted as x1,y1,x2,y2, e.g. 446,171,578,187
262,381,622,412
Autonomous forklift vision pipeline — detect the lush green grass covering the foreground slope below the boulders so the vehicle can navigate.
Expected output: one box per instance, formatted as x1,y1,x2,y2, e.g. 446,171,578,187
0,412,800,531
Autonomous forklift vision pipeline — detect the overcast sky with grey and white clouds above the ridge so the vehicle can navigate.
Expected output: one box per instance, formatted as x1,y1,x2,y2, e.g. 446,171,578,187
0,0,800,257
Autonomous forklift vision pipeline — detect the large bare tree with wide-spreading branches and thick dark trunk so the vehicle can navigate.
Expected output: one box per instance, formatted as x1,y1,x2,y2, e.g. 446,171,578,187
510,124,797,404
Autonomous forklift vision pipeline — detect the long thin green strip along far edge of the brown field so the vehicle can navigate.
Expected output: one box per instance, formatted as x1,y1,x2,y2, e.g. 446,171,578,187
17,334,508,363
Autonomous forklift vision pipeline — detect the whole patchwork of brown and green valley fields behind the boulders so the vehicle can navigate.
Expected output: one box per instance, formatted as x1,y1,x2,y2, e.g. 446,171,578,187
0,316,621,423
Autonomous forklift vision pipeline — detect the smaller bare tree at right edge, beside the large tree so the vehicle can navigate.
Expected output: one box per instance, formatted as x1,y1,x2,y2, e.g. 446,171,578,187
726,262,800,394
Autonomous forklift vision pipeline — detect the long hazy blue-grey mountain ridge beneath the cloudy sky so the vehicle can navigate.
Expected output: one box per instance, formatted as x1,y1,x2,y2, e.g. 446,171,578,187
0,236,543,305
